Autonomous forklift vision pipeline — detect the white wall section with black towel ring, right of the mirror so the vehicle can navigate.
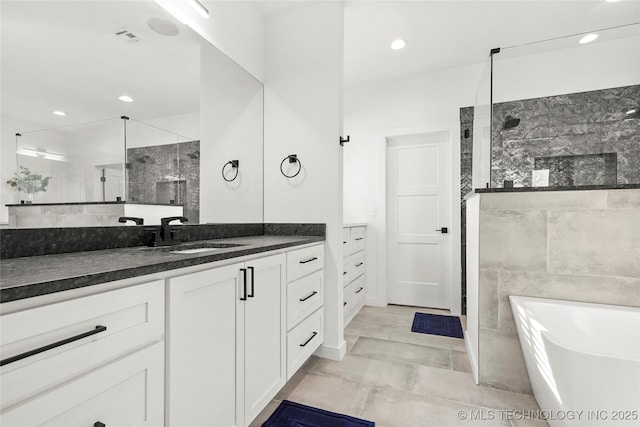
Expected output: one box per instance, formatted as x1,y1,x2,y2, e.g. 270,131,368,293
264,2,345,359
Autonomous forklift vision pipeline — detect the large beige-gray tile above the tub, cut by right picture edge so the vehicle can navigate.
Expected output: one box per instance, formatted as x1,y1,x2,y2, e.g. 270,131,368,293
548,210,640,277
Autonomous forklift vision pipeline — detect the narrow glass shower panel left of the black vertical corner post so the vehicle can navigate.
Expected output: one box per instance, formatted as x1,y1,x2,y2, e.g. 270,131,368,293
472,58,491,188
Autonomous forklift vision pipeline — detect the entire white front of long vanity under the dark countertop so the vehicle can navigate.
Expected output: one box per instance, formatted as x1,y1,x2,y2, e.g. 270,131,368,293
0,243,324,427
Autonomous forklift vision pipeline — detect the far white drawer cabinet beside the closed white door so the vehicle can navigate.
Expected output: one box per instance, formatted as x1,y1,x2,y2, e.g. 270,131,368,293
342,225,366,327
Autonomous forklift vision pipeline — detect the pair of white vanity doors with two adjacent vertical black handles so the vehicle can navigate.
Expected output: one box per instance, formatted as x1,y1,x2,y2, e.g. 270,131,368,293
167,254,286,427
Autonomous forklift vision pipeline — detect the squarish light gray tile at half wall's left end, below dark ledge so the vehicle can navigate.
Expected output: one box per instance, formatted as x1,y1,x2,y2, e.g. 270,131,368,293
480,210,547,271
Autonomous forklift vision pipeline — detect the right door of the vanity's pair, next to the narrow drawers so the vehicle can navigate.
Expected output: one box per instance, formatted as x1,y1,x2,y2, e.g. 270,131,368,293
239,255,286,425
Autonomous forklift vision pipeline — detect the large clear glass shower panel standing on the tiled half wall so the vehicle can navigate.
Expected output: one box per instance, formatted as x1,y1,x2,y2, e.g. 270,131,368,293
490,24,640,188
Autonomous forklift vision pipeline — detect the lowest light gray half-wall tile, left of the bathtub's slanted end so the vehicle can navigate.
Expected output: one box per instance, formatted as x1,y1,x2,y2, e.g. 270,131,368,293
478,328,532,394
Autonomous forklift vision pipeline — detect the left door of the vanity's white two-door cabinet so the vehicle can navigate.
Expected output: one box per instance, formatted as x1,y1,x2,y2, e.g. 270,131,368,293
166,264,243,427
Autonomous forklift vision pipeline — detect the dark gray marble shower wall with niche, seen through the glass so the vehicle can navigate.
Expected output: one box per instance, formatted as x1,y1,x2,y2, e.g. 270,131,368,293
492,85,640,188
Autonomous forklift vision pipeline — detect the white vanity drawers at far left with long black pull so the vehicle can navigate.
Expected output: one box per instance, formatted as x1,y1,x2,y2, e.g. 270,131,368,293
0,280,164,427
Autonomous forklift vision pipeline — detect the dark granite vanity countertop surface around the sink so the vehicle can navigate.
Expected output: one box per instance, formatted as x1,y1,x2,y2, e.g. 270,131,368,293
0,235,325,303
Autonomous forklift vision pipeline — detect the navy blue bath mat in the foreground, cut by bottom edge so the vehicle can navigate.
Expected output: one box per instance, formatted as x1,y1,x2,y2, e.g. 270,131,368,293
262,400,376,427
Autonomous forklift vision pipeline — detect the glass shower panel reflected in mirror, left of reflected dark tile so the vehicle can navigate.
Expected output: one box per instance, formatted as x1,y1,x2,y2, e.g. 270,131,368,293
10,118,125,203
